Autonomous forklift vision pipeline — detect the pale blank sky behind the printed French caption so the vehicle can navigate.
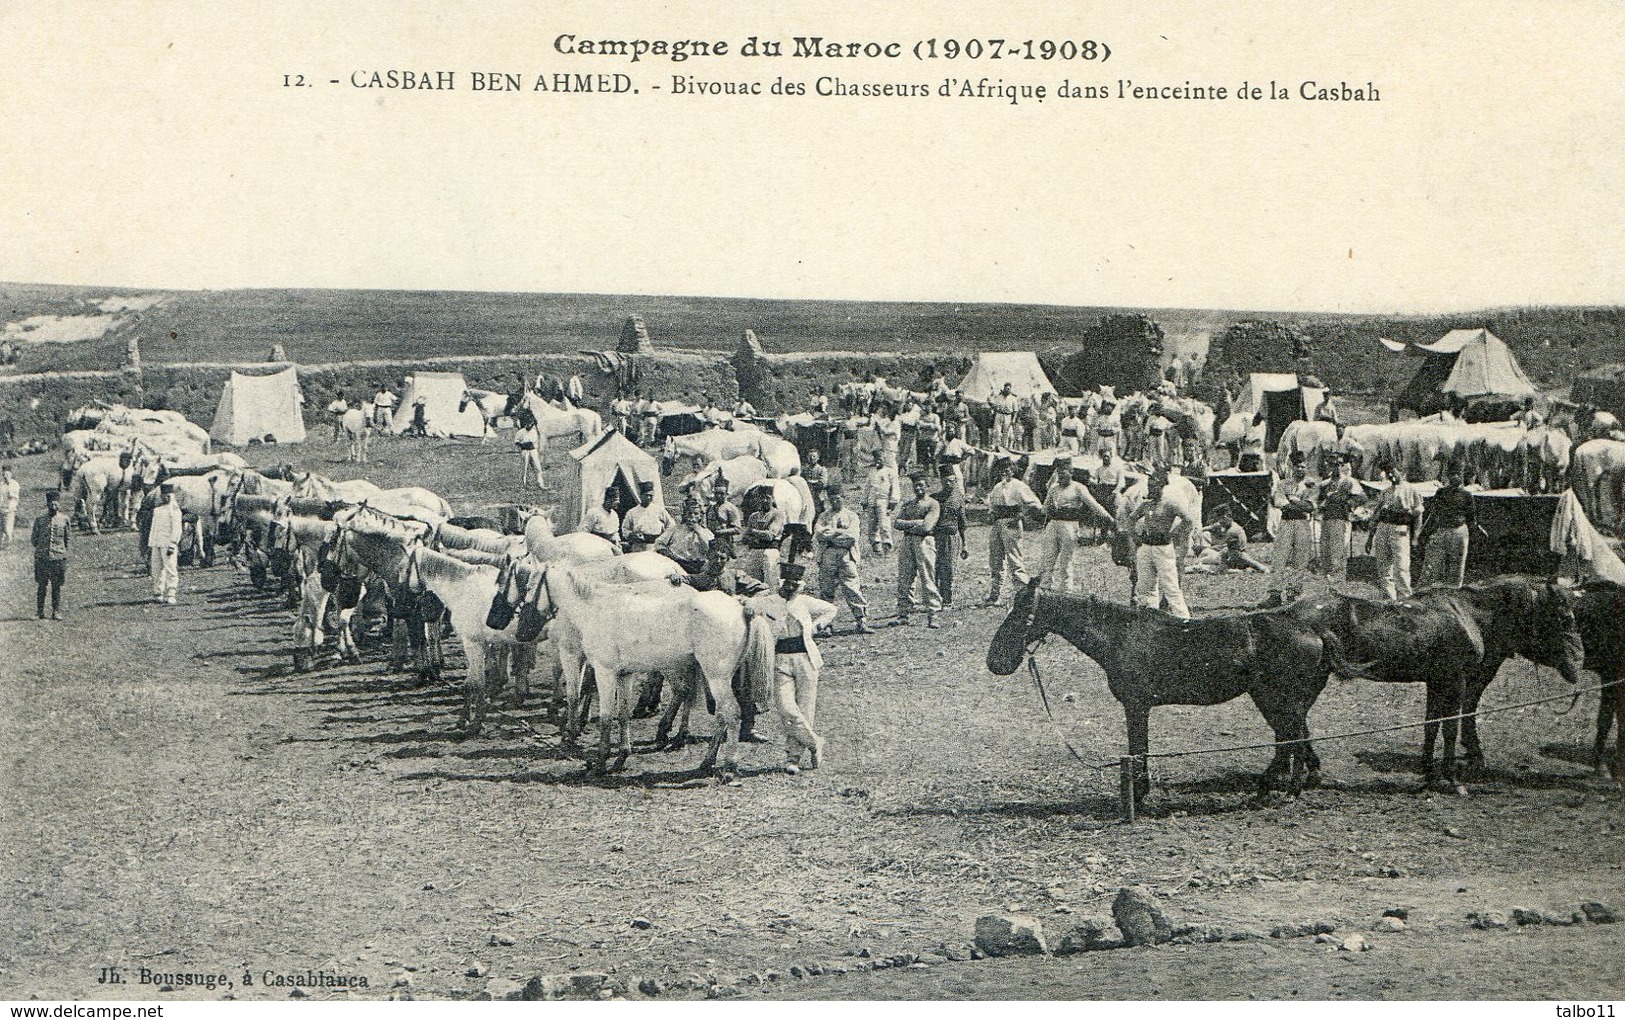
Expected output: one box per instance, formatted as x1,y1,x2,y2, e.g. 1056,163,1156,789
0,0,1625,312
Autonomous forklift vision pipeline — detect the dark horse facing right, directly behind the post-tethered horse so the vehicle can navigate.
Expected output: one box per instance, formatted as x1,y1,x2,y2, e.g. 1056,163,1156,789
1290,577,1583,793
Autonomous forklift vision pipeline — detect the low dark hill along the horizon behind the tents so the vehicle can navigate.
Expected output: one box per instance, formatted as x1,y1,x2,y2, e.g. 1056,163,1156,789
0,284,1625,402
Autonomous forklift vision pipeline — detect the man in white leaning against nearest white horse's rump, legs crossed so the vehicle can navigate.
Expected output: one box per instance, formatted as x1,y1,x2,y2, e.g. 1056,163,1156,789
749,564,835,775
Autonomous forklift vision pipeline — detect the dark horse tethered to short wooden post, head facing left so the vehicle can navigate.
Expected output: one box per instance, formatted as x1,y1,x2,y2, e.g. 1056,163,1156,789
988,581,1354,801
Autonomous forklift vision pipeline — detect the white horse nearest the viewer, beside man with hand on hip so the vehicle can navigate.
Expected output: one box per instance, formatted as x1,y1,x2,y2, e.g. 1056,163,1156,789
538,565,774,773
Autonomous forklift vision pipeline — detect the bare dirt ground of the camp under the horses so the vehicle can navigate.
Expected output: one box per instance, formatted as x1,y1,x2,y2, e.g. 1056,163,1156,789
0,440,1625,1001
